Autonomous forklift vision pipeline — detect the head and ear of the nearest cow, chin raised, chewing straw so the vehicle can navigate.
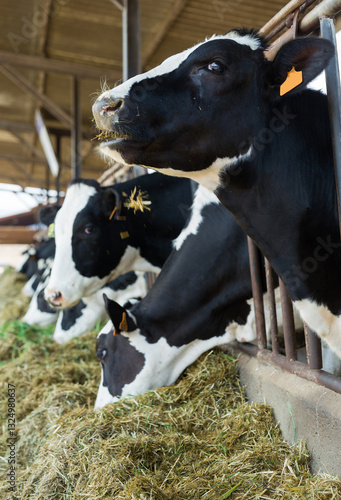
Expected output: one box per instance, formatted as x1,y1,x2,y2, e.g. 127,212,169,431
93,30,333,189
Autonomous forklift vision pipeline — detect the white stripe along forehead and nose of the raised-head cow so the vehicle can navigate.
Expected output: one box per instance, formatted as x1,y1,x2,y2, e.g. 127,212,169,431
99,31,261,99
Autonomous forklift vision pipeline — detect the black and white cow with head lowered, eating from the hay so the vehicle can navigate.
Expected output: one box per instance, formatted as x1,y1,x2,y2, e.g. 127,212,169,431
95,186,302,409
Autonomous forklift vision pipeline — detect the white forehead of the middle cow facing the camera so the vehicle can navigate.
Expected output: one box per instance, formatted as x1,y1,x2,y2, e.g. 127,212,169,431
55,184,97,237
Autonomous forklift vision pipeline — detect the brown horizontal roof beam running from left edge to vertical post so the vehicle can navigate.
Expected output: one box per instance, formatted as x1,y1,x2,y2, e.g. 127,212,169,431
0,50,122,80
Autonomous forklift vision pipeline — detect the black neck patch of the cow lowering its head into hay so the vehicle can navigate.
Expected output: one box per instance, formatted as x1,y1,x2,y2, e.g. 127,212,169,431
132,204,251,346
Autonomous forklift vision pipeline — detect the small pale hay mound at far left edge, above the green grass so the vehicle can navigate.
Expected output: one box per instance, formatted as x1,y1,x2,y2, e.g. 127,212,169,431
0,267,31,325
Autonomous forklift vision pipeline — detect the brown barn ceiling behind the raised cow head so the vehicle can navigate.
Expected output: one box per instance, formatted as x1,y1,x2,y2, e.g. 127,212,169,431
0,0,336,188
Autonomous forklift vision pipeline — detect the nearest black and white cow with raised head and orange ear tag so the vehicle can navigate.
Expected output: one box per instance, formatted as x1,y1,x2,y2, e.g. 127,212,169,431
93,30,341,356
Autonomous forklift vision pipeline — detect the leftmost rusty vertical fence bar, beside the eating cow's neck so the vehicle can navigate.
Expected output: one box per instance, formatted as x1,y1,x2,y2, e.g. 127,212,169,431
247,236,266,349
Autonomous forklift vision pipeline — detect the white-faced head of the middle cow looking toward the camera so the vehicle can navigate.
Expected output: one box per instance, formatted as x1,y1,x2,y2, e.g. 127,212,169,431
45,180,135,308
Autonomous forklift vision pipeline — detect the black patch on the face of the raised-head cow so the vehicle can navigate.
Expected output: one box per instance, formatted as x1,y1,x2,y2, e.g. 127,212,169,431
101,39,266,171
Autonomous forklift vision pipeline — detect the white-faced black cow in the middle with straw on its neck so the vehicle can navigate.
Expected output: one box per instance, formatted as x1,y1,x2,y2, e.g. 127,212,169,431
45,174,192,308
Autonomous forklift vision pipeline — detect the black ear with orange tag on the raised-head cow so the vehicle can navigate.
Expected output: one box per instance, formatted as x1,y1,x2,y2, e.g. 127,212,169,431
268,38,335,95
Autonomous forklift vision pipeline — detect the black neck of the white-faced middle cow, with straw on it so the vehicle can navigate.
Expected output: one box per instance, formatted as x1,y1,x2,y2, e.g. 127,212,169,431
113,173,192,268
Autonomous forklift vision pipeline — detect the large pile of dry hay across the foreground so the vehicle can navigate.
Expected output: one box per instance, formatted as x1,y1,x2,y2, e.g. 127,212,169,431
0,324,341,500
